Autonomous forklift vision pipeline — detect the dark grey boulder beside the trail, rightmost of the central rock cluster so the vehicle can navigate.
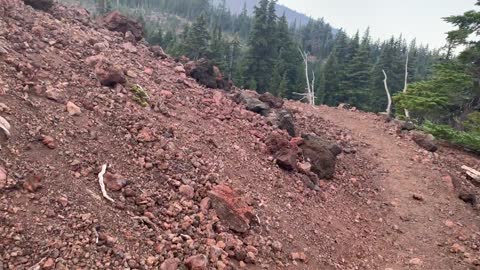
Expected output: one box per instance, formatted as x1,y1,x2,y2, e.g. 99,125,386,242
300,134,342,179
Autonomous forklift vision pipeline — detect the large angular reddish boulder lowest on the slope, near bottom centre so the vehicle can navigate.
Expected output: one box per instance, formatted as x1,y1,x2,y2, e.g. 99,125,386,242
208,185,254,233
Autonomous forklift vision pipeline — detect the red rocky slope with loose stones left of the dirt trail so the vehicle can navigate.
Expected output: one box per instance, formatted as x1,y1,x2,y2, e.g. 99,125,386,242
0,0,478,269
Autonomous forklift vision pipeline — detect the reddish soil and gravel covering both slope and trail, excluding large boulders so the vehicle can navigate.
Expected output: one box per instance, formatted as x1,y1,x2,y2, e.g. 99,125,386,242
0,0,480,270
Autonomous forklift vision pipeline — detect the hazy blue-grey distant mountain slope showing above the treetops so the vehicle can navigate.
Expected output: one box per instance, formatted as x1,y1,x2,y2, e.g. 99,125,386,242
214,0,310,25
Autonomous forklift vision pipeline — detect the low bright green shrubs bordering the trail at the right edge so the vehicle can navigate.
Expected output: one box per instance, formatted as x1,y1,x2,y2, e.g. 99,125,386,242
423,122,480,152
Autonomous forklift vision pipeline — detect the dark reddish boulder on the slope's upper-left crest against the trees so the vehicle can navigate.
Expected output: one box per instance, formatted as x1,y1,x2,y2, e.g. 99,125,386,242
100,11,144,41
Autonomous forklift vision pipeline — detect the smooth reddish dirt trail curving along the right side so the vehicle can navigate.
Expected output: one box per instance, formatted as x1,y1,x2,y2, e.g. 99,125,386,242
318,104,479,269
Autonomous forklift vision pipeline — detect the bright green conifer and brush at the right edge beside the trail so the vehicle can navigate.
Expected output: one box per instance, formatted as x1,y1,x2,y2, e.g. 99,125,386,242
394,1,480,153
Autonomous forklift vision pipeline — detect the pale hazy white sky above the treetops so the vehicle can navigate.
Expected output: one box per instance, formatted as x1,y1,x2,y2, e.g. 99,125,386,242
279,0,476,47
